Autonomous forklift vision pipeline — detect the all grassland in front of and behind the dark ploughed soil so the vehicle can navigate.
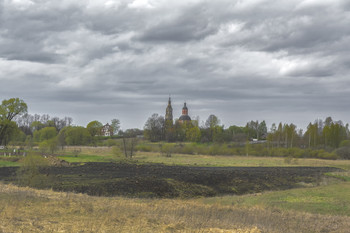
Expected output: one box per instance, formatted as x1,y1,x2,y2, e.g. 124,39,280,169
0,148,350,233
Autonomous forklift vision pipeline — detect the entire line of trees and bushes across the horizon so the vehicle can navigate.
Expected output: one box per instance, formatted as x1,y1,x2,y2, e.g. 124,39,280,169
0,98,350,159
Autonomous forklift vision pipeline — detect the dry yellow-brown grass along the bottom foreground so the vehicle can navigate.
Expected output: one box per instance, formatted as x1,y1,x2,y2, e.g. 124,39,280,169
0,183,350,233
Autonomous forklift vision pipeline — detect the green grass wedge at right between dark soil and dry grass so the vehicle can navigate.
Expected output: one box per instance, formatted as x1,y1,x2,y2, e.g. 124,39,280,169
202,181,350,216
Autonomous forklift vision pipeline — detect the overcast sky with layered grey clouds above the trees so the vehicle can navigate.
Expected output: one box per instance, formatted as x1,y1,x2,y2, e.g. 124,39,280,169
0,0,350,129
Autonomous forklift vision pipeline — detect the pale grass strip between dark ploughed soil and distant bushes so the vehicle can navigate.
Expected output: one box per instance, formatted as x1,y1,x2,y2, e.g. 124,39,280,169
53,147,350,170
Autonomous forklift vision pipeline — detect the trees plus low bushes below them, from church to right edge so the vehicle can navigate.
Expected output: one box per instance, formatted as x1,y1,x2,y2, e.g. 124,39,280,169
144,114,350,159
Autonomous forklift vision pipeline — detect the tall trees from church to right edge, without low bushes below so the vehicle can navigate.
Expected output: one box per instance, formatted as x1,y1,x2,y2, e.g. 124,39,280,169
144,114,350,148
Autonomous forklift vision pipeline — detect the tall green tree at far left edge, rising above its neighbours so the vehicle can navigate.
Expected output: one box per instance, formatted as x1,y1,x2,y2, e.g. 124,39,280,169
0,98,28,145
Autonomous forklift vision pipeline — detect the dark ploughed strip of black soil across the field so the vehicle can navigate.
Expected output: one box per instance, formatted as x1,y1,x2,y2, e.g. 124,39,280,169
0,163,339,198
